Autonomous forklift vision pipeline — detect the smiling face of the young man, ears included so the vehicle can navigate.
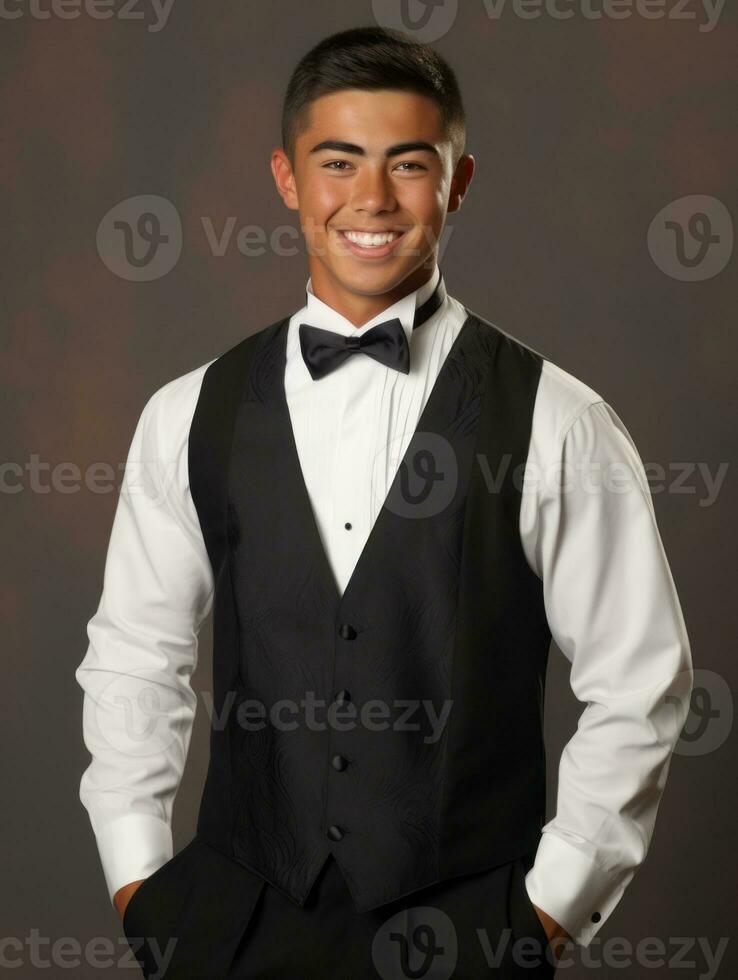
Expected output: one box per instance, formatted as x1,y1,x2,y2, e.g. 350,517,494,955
272,89,473,308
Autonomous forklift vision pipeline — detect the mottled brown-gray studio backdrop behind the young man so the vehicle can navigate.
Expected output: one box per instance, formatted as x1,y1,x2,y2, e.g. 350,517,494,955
0,0,738,978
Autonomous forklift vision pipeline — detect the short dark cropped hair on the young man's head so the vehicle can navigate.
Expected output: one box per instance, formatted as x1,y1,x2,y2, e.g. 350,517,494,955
282,26,466,165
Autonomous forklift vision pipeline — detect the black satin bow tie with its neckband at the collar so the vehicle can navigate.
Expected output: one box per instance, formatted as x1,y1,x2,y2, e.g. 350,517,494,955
299,276,445,381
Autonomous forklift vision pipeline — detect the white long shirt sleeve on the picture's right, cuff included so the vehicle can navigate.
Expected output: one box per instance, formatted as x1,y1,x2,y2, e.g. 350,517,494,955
525,386,693,947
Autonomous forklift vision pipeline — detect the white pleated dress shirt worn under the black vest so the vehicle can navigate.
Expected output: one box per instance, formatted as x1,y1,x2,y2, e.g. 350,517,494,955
75,266,692,946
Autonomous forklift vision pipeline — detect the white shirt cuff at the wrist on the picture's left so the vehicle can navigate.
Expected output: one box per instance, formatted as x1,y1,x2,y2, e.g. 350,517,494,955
90,813,174,902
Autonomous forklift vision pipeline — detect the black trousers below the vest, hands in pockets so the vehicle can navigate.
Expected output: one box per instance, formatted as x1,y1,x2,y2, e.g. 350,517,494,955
123,838,555,980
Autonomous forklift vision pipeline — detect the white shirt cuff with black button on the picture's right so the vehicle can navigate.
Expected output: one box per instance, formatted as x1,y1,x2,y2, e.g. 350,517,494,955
525,831,633,948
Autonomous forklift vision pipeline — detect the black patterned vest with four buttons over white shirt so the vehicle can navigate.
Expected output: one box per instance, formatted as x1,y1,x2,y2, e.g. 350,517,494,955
189,310,551,912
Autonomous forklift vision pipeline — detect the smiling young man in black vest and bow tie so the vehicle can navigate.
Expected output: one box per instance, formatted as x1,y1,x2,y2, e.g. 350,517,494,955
77,28,692,980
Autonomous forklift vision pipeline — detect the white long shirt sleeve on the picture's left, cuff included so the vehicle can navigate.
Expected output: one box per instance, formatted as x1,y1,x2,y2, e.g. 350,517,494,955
75,370,213,900
